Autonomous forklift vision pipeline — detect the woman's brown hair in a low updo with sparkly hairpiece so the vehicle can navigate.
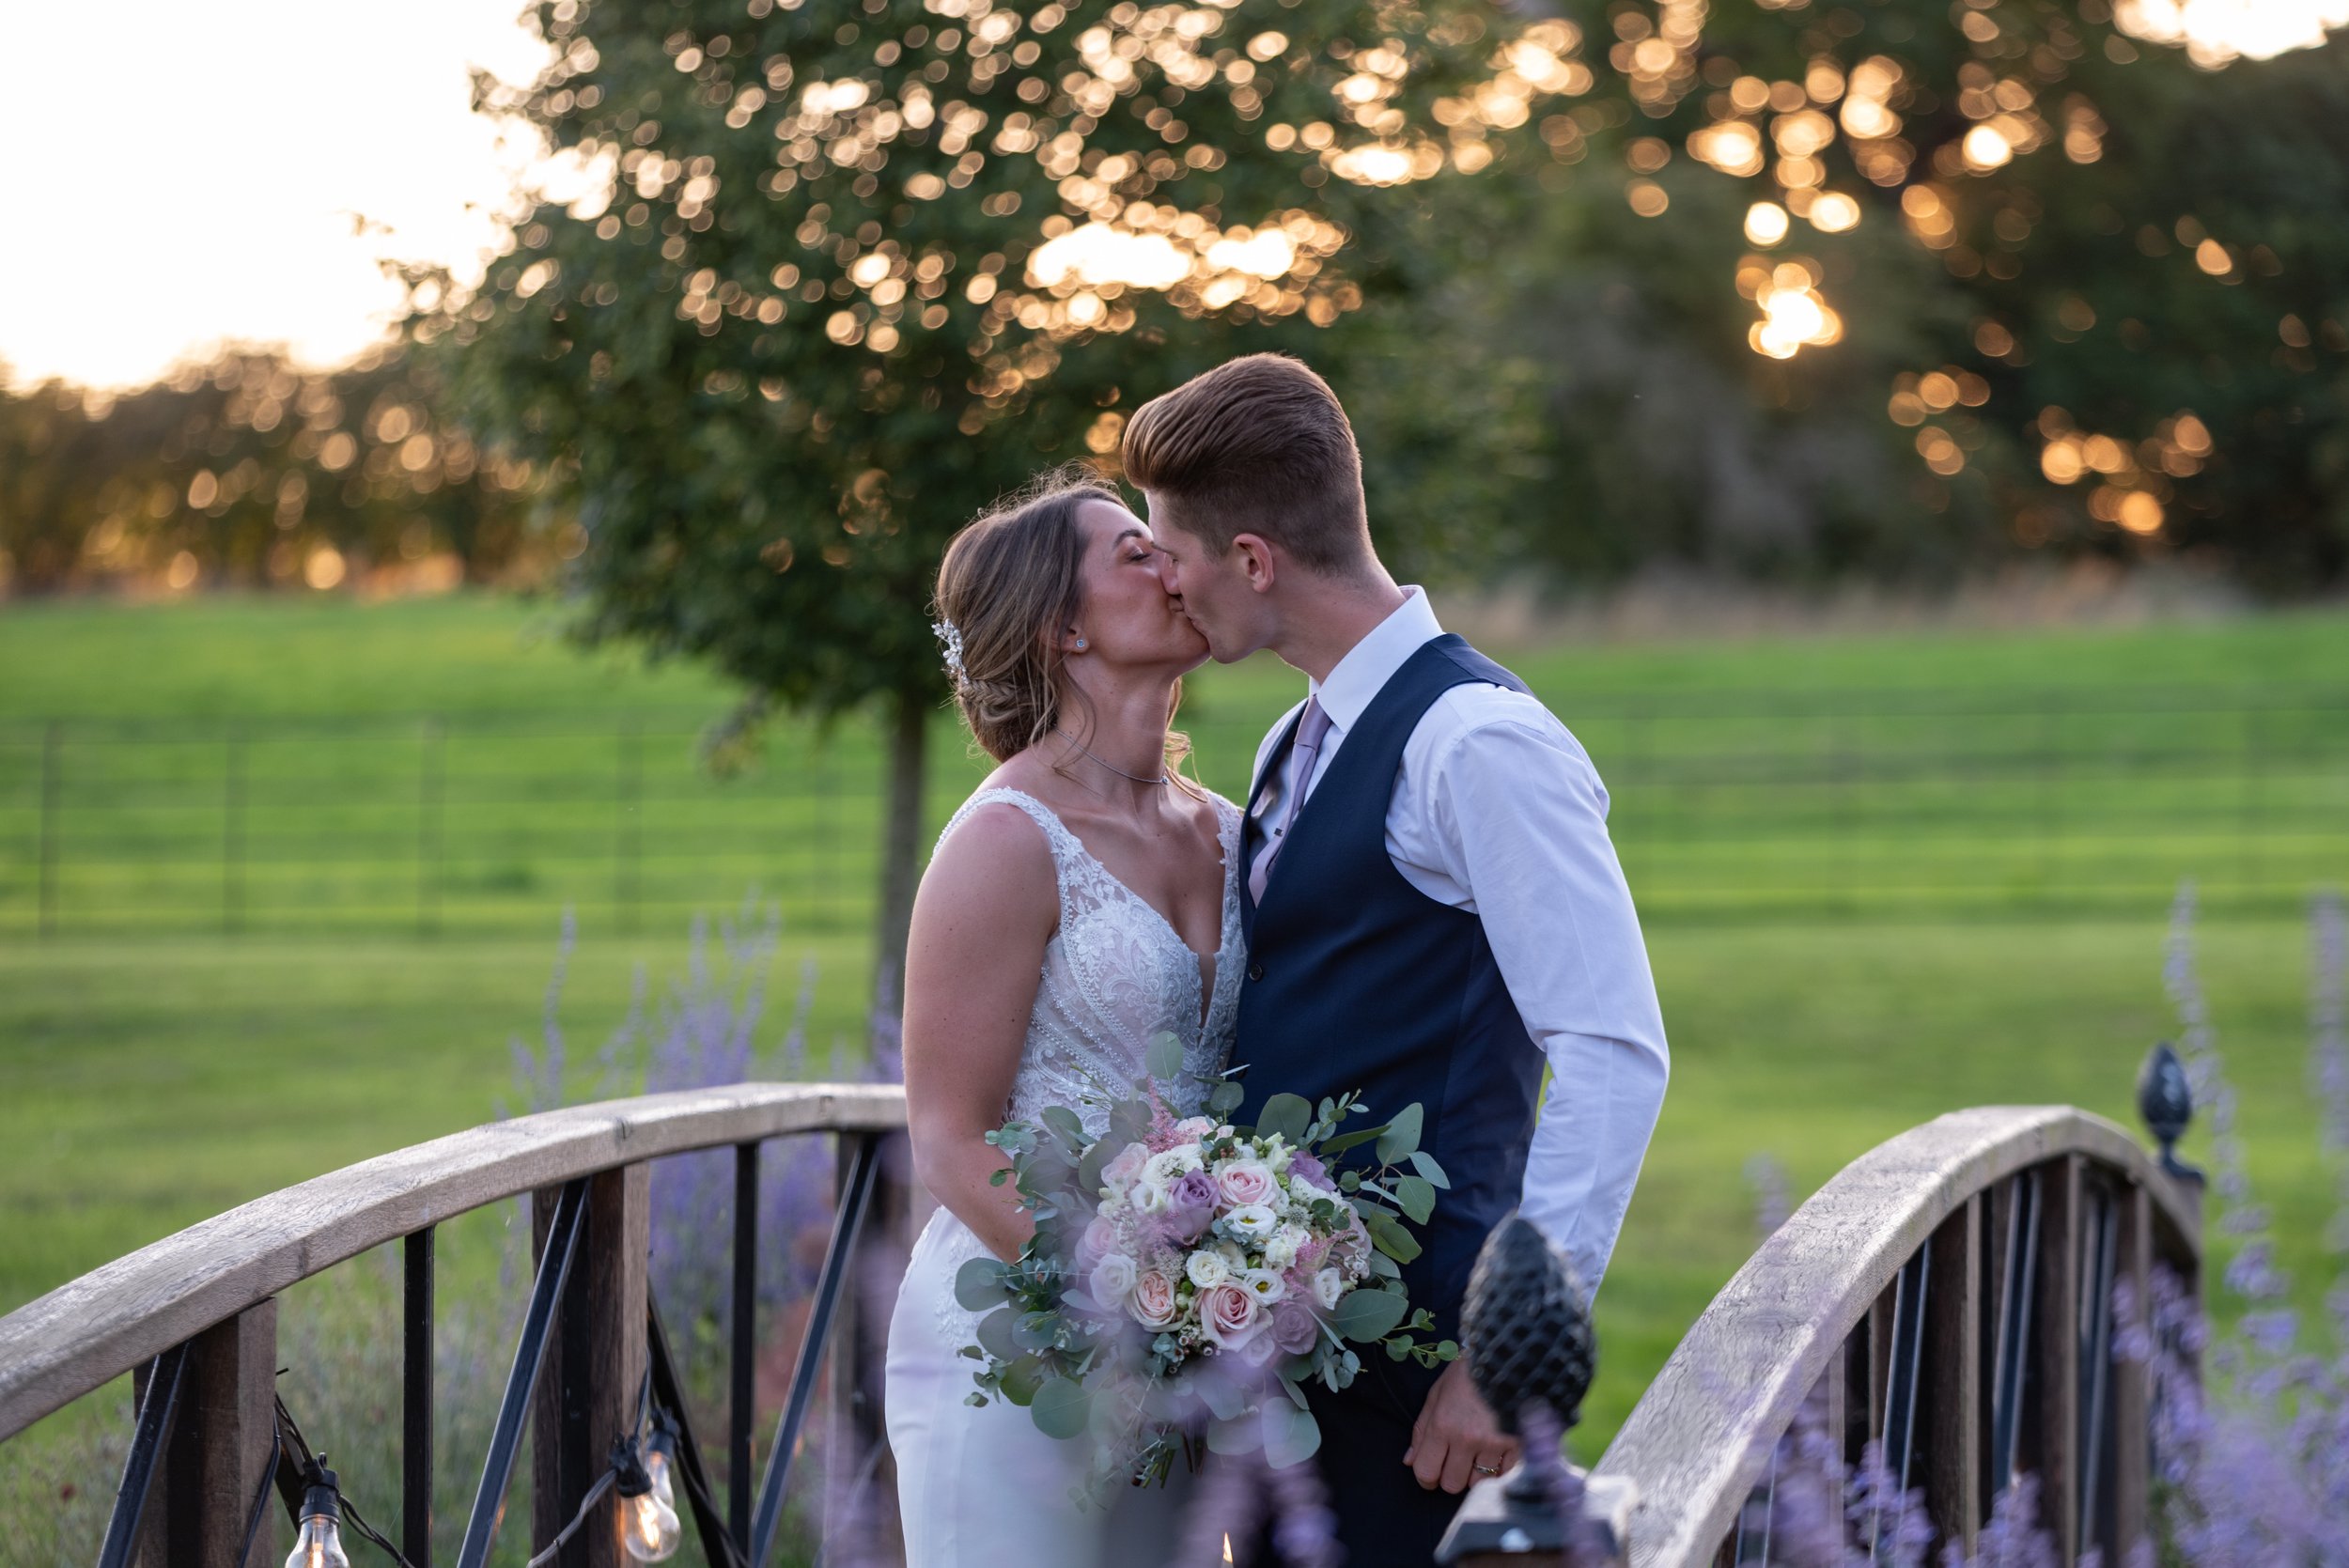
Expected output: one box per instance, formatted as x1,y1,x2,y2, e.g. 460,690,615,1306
938,467,1126,763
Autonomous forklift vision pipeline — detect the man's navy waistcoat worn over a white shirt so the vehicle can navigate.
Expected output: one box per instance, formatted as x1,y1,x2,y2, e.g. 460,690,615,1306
1234,634,1541,1333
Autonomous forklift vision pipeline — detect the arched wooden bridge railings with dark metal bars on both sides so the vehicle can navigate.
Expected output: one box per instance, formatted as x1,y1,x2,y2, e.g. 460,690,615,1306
0,1084,2201,1568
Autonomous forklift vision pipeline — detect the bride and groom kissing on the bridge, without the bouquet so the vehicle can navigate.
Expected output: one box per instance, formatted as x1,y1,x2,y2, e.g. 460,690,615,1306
886,354,1668,1568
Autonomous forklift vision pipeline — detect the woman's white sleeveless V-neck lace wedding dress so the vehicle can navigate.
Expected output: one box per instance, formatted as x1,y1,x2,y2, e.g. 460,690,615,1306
888,788,1245,1568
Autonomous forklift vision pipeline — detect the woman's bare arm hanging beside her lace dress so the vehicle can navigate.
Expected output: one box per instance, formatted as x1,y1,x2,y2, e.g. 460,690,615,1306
905,805,1060,1261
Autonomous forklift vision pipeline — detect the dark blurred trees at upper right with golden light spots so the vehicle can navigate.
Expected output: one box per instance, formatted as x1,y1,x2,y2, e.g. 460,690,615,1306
1391,0,2349,592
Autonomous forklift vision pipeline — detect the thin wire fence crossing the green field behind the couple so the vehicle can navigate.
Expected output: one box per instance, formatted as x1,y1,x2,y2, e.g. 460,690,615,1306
0,686,2349,939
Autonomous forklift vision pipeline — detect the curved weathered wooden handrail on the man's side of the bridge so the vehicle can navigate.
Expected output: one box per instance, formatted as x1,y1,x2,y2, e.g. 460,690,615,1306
1595,1106,2201,1568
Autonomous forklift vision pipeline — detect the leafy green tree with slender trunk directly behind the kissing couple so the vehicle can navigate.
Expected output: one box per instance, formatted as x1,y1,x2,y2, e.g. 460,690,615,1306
412,0,1593,1004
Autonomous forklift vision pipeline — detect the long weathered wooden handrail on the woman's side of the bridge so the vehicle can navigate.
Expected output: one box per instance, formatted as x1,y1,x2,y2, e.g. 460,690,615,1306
0,1082,905,1441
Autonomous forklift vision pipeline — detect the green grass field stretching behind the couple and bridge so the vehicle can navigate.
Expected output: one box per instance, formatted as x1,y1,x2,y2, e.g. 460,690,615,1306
0,584,2349,1469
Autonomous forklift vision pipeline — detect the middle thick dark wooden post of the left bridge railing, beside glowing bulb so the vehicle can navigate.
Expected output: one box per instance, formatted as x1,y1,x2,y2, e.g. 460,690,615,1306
531,1162,653,1568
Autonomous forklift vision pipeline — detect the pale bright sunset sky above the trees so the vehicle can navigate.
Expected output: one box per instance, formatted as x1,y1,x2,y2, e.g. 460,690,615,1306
0,0,2349,387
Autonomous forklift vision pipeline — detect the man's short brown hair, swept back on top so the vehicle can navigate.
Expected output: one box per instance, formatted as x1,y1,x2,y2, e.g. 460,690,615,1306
1121,354,1372,573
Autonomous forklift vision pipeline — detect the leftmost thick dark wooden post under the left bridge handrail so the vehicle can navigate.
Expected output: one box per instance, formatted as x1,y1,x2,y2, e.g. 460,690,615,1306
134,1298,277,1568
